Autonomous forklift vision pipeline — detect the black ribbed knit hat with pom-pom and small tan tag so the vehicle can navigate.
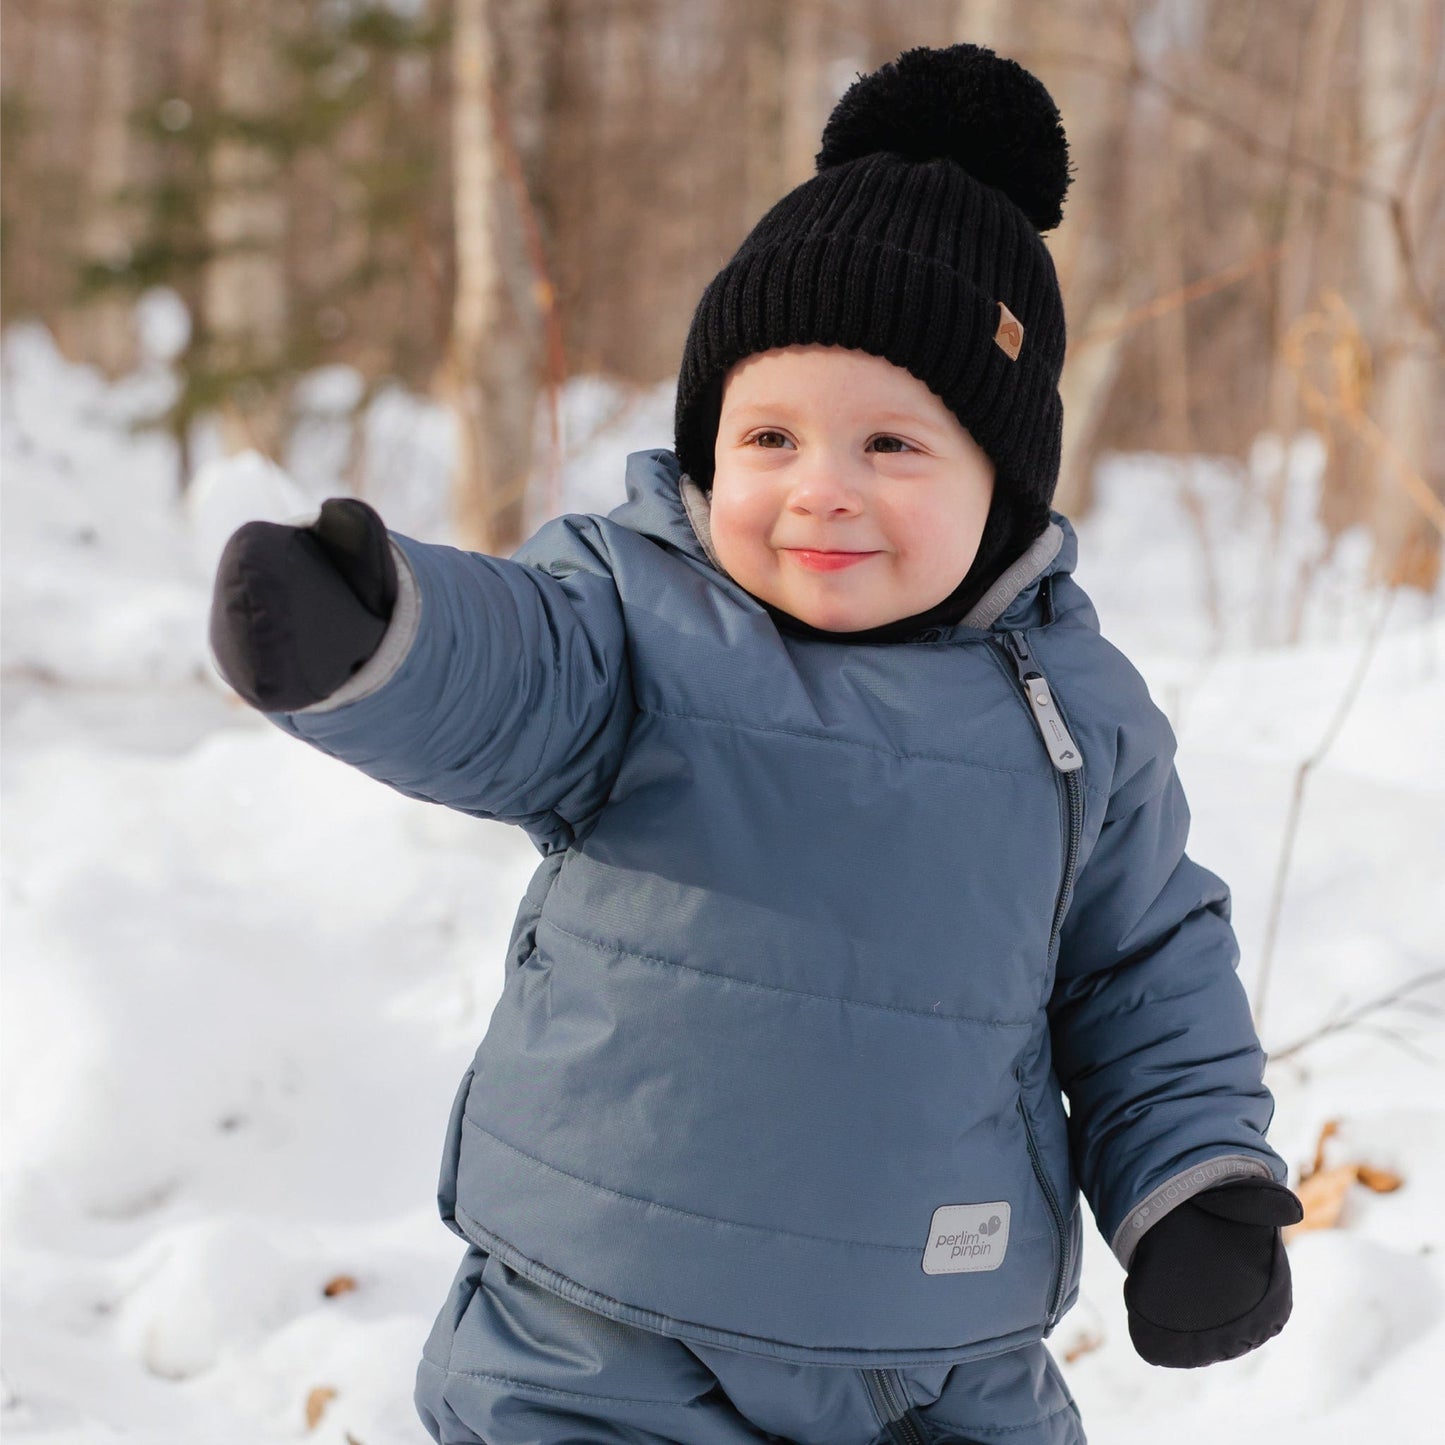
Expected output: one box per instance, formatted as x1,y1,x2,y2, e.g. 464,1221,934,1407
675,45,1069,561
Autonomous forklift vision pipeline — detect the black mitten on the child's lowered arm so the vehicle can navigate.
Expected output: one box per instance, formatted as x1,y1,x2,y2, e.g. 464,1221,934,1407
1124,1179,1305,1370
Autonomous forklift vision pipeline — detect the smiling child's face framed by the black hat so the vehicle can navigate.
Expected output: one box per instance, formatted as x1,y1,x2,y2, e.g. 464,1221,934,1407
711,345,994,631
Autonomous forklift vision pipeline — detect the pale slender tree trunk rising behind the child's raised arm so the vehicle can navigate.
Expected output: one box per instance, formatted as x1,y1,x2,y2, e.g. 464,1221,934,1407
439,0,538,555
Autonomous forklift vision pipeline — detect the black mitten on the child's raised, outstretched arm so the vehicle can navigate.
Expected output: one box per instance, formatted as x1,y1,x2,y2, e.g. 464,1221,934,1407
211,497,396,712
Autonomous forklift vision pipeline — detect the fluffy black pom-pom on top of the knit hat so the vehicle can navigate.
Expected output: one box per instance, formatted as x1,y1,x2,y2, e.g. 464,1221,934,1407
818,45,1069,231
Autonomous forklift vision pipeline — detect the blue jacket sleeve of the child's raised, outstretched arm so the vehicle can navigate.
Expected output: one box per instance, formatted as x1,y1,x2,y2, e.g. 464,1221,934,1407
266,516,634,853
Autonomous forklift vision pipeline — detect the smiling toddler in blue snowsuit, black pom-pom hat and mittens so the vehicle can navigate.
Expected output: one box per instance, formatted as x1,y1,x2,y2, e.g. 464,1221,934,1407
211,45,1301,1445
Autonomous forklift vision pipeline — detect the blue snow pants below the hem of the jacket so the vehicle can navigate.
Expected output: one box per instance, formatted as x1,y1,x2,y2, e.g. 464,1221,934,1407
416,1246,1085,1445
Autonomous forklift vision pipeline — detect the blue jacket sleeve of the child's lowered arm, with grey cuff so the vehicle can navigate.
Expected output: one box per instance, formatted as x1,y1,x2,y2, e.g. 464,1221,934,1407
1049,702,1287,1269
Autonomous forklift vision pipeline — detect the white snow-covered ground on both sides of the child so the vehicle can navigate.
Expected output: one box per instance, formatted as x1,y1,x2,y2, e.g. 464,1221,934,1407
0,307,1445,1445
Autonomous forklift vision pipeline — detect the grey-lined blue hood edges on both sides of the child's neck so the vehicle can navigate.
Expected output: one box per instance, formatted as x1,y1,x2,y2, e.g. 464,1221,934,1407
608,448,1078,636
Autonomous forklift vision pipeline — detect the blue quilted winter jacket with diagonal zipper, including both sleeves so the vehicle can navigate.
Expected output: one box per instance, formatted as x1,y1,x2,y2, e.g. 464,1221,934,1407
270,449,1287,1366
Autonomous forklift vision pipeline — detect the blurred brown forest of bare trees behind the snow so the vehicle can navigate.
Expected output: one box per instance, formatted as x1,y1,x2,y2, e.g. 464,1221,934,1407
0,0,1445,598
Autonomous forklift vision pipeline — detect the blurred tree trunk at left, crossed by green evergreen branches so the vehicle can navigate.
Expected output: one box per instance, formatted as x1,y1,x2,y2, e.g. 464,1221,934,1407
202,0,286,457
